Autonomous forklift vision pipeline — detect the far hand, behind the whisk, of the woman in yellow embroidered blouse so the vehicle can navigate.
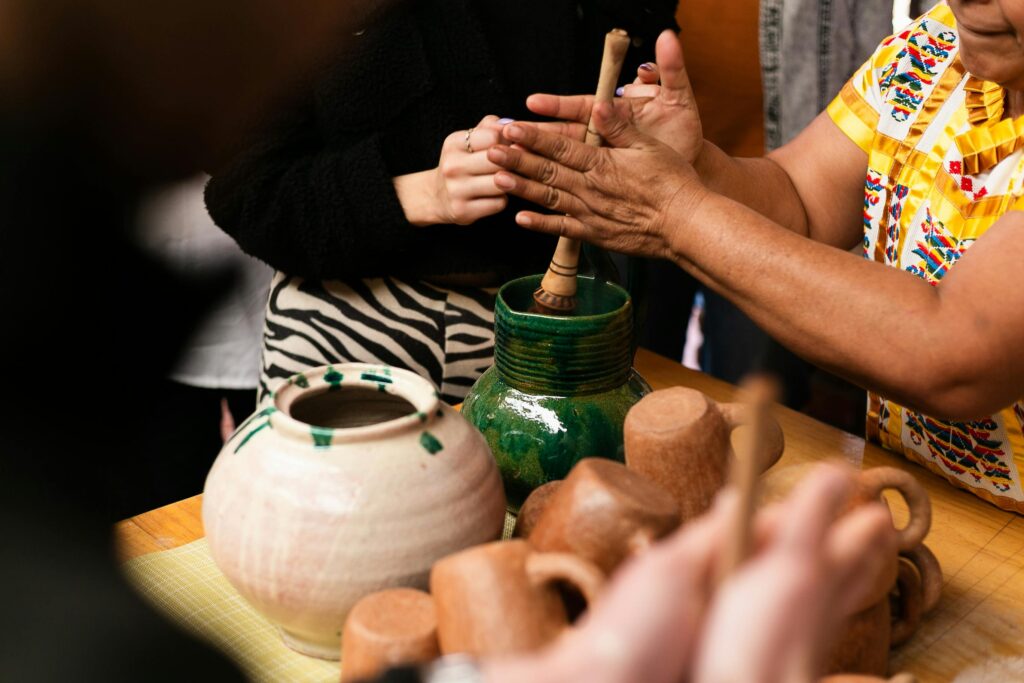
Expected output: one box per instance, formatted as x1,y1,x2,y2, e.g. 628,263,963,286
526,31,703,164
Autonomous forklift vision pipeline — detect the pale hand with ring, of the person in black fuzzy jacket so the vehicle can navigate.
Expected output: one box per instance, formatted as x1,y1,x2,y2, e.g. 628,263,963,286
394,116,508,226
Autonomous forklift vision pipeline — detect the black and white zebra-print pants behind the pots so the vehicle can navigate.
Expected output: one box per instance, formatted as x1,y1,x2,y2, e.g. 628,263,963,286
260,272,497,403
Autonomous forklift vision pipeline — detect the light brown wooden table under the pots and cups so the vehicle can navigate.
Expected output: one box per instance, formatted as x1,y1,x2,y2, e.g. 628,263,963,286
117,350,1024,682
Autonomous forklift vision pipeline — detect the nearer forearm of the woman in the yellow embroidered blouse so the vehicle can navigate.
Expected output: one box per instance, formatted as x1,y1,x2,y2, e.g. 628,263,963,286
671,189,1010,418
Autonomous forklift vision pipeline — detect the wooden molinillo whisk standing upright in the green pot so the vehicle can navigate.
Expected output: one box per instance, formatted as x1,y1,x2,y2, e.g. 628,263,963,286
534,29,630,314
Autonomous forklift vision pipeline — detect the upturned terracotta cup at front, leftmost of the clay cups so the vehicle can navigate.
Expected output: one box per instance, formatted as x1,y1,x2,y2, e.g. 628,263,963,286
341,588,440,683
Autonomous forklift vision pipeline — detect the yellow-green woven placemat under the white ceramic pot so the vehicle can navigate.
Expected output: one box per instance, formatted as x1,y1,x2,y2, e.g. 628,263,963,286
122,515,515,683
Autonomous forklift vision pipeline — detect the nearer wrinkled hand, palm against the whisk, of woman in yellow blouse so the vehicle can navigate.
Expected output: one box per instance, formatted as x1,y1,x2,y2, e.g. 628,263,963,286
487,103,708,258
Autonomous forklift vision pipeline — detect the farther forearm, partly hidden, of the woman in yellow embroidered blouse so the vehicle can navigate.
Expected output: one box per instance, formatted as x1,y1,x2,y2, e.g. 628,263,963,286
694,140,808,236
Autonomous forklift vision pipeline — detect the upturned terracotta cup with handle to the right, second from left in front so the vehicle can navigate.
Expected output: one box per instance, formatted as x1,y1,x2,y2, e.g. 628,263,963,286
430,539,604,656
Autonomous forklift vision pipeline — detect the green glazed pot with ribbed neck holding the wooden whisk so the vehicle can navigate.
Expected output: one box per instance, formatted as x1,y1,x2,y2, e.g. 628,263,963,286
462,275,650,511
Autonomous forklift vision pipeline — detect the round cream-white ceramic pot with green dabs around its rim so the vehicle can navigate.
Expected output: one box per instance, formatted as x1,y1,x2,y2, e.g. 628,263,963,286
203,364,505,659
